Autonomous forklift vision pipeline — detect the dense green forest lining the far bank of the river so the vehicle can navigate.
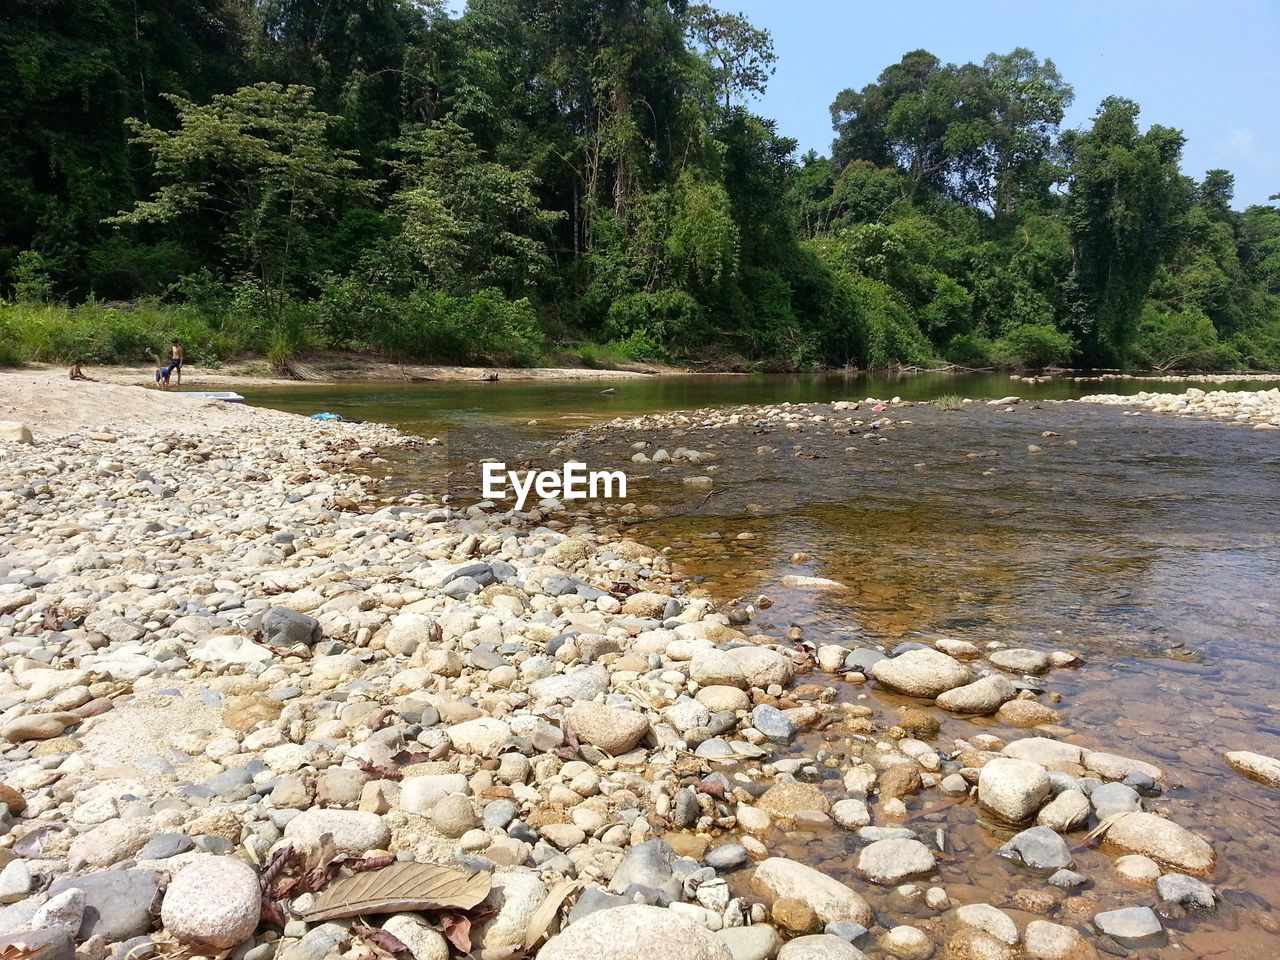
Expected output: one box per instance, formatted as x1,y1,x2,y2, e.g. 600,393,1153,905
0,0,1280,369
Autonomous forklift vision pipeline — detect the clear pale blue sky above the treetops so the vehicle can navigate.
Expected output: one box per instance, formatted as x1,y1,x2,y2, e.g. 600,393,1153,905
732,0,1280,209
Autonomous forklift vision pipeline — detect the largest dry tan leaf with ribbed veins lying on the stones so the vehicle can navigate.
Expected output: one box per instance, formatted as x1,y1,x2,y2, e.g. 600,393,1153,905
302,863,493,923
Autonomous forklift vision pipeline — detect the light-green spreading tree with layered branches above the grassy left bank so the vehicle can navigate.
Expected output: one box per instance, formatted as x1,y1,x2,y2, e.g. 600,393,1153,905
110,83,372,319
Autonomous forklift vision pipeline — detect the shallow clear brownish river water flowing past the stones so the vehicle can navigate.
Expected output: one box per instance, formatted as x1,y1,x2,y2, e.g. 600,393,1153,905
246,376,1280,960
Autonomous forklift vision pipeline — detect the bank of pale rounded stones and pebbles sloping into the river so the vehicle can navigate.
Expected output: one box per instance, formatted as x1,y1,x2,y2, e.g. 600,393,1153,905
0,391,1267,960
